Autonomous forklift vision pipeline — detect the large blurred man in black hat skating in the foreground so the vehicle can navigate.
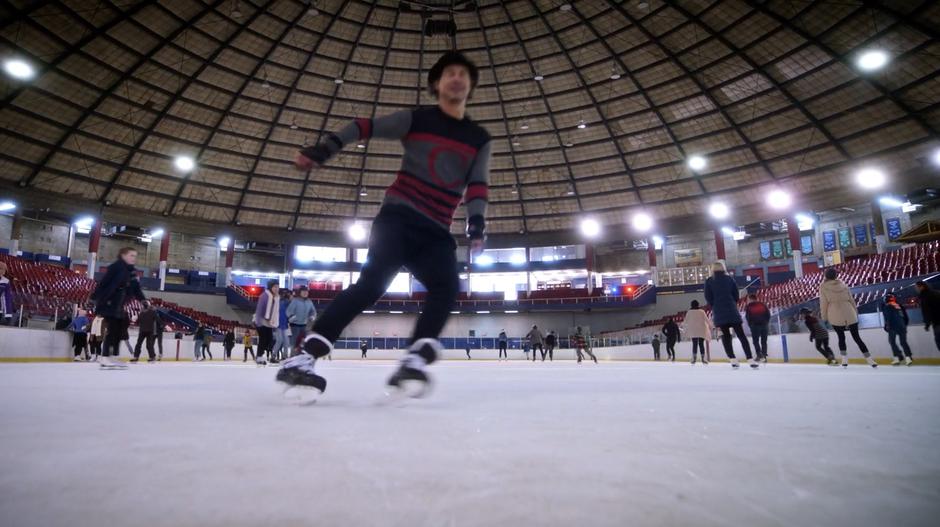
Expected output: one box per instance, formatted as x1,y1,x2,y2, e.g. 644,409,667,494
277,52,490,397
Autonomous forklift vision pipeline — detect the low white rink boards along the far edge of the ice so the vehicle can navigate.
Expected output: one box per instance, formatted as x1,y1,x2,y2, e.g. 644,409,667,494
0,327,940,364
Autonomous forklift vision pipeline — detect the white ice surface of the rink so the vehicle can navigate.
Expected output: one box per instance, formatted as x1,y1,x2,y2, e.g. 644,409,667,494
0,361,940,527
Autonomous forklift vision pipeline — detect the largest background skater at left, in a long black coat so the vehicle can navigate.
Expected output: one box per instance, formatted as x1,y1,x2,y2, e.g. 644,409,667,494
91,247,147,369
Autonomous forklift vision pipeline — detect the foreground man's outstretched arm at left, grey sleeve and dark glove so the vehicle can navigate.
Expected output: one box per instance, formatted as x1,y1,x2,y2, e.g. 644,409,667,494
295,110,412,170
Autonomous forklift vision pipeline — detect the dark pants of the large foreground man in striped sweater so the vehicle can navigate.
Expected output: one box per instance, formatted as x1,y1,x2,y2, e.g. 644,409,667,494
313,205,460,362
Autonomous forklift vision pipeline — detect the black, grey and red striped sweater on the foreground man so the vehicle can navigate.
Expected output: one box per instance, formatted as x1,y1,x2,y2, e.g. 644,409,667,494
301,106,491,239
